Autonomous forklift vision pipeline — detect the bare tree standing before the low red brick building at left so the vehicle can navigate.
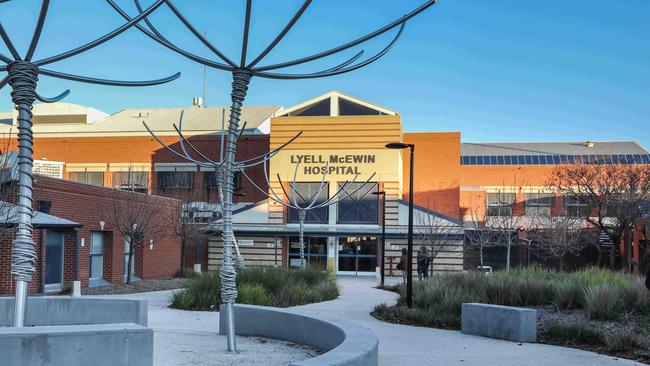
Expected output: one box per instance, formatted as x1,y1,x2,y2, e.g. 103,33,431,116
108,169,172,283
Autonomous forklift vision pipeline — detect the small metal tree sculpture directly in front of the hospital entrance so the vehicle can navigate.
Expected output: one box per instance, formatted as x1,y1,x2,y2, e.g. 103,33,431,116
242,163,375,268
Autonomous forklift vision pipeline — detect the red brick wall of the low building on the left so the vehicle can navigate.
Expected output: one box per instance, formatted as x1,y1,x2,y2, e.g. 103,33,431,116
0,176,181,294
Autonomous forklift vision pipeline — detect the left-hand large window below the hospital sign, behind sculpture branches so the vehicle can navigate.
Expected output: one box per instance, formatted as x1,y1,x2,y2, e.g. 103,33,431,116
287,182,329,224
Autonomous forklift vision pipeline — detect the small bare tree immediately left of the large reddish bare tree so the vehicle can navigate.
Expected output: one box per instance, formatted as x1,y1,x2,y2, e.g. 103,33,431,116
531,215,598,271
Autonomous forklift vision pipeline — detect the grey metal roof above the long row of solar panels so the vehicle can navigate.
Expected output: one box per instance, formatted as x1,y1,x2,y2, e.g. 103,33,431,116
460,141,648,156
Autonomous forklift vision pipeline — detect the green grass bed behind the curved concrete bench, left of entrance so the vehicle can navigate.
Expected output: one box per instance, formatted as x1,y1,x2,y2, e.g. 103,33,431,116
171,267,339,310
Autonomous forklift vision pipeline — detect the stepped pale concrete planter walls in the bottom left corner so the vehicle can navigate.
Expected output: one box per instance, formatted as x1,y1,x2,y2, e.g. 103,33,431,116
0,296,153,366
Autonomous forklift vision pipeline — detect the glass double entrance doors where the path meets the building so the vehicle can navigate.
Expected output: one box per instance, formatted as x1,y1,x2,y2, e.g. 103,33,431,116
338,237,377,274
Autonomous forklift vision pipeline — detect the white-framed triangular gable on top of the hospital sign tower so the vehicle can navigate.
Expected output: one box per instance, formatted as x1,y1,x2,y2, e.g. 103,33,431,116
274,90,397,117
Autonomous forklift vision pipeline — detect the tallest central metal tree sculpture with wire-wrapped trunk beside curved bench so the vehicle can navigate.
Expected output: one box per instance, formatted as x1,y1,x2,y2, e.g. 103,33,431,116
106,0,435,352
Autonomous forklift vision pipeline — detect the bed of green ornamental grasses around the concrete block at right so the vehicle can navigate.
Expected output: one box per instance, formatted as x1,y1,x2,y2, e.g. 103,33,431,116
373,267,650,362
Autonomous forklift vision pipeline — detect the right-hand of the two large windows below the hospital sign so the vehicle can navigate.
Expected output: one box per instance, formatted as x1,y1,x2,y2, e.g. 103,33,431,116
337,183,379,224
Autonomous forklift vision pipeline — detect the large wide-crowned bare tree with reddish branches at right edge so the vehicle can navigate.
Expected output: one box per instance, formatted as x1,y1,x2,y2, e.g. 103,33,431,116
549,164,650,270
